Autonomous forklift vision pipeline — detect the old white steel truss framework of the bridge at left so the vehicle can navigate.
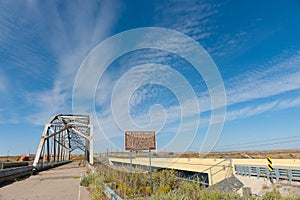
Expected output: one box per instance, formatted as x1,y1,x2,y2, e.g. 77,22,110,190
33,114,94,168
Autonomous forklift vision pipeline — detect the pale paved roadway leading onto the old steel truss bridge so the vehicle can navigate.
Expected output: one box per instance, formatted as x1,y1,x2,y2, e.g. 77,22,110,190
0,163,89,200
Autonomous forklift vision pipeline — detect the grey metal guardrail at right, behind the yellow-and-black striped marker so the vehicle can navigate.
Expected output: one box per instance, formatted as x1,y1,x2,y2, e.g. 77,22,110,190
234,165,300,182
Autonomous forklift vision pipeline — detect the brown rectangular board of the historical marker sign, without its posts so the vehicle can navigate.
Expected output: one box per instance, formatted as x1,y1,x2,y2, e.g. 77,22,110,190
125,131,156,151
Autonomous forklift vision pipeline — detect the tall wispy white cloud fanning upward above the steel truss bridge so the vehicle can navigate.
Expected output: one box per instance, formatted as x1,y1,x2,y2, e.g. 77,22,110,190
22,1,119,124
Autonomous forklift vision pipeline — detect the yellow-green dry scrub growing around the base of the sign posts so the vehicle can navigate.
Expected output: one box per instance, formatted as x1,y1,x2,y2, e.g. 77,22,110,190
86,166,240,200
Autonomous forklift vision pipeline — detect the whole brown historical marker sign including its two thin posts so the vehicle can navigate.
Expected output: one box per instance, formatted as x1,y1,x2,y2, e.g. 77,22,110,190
125,131,156,195
